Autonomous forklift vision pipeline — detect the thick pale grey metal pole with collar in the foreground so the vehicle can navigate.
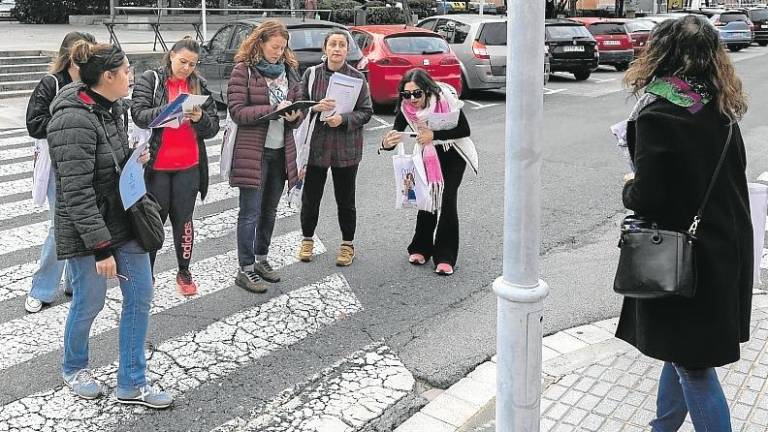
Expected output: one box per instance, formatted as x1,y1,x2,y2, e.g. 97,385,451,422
493,1,549,432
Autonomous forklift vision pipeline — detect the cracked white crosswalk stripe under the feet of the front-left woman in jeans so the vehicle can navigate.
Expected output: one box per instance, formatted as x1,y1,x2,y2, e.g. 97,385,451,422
0,274,362,432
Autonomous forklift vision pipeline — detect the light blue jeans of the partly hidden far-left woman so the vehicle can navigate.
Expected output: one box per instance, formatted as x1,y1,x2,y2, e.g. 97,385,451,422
29,171,72,303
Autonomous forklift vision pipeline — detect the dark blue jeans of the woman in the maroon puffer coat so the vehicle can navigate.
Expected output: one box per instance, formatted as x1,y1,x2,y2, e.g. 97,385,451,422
237,148,286,267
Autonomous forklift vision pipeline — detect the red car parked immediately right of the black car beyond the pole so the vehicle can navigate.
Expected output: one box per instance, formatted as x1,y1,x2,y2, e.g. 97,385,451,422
573,18,635,71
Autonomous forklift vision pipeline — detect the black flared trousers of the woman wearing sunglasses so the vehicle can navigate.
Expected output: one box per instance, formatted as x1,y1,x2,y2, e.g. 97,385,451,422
408,146,467,266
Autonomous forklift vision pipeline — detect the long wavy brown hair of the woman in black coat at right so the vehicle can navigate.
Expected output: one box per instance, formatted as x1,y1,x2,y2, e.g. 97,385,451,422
624,15,747,121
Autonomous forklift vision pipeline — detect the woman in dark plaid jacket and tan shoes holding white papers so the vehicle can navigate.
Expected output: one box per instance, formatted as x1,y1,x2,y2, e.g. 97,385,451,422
299,30,373,266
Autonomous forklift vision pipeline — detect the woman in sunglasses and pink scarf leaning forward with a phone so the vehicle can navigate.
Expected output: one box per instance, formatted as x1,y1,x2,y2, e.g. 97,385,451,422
381,68,478,276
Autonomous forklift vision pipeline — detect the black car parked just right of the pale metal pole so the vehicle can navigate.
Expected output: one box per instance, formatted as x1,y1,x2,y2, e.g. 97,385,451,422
544,19,599,81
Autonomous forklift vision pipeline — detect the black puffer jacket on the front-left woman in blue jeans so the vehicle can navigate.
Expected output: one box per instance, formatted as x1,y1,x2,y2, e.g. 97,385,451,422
48,83,133,259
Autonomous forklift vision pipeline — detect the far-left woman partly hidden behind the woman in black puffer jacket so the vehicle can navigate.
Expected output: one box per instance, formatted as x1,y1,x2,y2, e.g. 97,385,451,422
24,32,96,313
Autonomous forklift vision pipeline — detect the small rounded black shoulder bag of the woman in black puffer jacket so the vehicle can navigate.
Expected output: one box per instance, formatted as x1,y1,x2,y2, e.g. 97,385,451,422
104,127,165,252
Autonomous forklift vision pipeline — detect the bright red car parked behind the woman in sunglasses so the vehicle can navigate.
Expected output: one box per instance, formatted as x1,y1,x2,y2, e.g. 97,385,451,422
350,25,461,105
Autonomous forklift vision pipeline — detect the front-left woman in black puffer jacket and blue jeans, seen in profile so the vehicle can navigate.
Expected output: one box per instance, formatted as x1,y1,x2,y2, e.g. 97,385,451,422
48,41,173,408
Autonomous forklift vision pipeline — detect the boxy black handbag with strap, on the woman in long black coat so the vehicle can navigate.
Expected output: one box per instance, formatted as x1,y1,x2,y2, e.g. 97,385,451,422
613,125,733,299
